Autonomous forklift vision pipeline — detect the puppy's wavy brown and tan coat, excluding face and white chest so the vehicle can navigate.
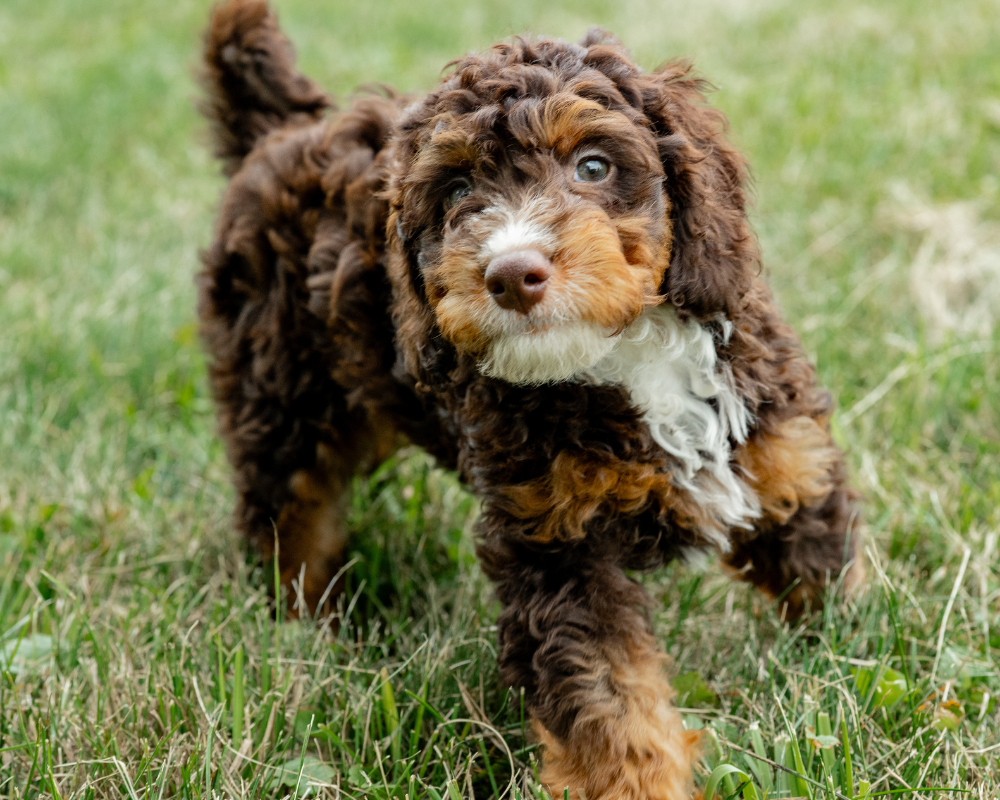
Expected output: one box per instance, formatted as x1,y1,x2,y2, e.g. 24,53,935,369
199,0,856,800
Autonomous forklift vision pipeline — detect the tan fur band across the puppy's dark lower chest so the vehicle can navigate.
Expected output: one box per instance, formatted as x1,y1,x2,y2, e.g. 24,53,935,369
498,450,712,543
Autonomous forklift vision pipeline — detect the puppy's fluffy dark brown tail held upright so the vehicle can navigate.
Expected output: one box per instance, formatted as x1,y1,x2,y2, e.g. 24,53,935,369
200,0,332,175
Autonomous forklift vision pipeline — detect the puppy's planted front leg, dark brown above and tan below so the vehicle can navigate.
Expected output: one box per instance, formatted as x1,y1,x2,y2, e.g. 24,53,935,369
480,537,698,800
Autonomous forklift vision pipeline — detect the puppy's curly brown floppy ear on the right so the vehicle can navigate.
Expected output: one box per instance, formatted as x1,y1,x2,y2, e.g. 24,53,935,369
641,62,760,319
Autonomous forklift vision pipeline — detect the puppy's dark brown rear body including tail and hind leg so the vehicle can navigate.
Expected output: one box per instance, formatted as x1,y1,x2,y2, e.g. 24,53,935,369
199,0,448,608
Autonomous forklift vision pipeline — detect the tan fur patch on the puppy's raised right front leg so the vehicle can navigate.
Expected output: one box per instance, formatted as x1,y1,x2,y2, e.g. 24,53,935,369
736,417,839,524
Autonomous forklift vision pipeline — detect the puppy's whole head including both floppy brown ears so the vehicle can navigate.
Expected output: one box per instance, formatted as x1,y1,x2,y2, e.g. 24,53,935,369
389,32,757,384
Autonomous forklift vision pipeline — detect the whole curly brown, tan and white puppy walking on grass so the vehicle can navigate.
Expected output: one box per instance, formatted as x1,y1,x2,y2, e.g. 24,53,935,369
200,0,859,800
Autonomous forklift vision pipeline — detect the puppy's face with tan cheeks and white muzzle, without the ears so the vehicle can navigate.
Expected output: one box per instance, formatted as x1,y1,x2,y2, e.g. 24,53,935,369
394,87,670,383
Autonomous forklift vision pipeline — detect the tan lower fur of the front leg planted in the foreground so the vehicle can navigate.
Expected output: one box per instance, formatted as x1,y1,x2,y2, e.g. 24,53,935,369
532,636,700,800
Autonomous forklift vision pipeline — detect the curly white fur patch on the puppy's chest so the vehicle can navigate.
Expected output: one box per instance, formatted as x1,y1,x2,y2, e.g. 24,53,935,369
581,305,760,551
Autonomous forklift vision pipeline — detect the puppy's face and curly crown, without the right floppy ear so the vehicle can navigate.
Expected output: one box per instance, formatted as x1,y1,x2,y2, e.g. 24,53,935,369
390,40,752,384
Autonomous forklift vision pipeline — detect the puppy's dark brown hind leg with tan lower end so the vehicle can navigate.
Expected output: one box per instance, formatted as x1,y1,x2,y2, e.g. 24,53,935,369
201,236,382,610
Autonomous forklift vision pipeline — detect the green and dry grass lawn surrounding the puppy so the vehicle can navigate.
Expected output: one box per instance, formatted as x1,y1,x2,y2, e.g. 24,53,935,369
0,0,1000,800
